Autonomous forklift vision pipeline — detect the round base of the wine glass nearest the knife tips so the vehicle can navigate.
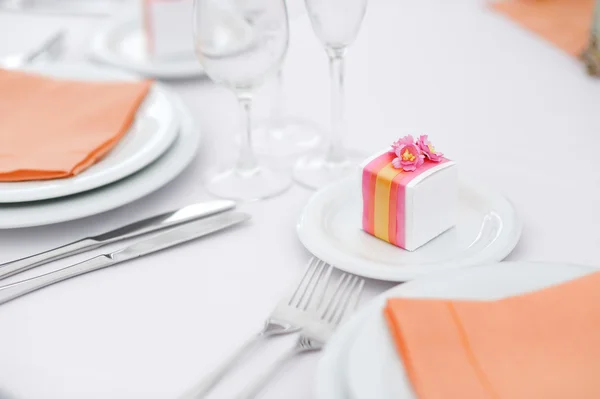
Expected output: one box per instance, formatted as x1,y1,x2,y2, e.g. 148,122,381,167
206,166,292,201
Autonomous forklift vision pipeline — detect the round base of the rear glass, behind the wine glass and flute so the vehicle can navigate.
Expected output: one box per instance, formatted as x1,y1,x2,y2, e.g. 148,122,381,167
252,117,323,160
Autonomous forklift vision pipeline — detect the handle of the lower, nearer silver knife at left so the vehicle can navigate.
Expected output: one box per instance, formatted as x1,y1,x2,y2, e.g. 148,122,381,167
0,255,113,305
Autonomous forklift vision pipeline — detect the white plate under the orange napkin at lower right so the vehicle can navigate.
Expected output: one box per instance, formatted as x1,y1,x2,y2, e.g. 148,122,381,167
316,261,599,399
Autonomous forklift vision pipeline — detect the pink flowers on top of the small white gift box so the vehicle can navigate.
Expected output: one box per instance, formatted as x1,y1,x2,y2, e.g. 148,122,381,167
390,134,444,172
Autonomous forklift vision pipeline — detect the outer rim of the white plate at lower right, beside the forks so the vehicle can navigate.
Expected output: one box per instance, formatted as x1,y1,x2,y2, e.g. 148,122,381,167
314,260,600,399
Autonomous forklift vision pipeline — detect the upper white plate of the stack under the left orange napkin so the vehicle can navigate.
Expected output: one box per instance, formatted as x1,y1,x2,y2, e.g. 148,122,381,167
0,64,179,203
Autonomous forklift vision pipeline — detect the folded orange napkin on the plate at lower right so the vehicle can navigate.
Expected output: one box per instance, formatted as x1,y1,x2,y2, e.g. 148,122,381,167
384,273,600,399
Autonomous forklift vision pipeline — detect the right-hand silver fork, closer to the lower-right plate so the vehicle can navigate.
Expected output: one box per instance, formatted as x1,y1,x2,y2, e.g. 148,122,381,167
237,273,365,399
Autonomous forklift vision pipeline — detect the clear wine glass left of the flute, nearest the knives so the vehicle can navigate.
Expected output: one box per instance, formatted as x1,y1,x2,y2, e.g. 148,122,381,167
194,0,291,201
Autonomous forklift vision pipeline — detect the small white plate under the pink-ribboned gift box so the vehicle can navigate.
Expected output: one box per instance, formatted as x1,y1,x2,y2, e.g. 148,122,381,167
297,178,521,281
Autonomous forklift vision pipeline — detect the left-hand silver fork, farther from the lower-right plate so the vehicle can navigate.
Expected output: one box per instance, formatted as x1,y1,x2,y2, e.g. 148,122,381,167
179,258,333,399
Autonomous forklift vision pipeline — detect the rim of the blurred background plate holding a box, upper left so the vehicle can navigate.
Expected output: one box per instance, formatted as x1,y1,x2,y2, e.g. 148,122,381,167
86,16,205,79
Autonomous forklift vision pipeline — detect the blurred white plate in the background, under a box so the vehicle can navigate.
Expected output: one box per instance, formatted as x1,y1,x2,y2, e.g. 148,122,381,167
88,17,204,79
